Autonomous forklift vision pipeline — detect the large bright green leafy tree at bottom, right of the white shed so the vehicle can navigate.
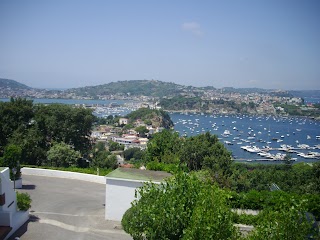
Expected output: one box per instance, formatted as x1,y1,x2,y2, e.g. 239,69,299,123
122,173,239,240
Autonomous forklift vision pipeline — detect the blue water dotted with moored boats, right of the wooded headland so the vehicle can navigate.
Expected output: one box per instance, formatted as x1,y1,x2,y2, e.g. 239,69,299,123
170,113,320,163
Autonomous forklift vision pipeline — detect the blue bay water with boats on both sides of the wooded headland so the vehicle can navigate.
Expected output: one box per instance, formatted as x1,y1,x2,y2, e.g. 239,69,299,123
0,99,320,163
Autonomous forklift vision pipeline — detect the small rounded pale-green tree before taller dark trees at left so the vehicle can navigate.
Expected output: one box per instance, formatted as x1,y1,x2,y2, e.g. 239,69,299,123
47,142,81,167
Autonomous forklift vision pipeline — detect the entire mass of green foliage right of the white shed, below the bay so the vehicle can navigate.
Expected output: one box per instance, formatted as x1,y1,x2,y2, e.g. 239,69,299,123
122,127,320,239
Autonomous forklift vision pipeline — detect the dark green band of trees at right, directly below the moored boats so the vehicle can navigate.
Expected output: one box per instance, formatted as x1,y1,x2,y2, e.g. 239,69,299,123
230,162,320,194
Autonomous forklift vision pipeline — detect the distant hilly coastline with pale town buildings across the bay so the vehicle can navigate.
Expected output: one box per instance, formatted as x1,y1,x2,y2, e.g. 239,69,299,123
0,79,320,118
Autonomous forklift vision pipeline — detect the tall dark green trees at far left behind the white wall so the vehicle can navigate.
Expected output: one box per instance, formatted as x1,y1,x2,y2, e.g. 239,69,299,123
0,98,94,165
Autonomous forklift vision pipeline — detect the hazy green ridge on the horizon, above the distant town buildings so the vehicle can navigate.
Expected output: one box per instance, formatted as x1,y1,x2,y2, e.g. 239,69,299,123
0,78,320,99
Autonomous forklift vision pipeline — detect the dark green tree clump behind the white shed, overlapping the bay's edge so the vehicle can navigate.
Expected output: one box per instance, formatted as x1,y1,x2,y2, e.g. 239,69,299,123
144,130,233,184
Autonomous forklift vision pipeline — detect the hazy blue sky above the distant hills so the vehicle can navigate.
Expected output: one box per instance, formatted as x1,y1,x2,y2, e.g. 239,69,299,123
0,0,320,89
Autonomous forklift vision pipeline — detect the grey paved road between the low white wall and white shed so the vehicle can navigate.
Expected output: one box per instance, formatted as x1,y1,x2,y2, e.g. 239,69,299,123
10,175,132,240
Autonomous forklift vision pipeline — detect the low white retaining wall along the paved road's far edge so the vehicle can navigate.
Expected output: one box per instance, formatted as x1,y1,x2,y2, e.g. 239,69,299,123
21,167,106,184
